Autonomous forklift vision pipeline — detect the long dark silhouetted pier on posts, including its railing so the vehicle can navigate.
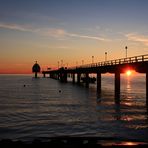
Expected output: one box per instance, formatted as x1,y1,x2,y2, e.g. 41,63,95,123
42,54,148,105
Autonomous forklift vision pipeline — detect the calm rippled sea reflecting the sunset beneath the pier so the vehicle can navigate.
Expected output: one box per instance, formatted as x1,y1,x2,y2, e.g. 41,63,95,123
0,74,148,141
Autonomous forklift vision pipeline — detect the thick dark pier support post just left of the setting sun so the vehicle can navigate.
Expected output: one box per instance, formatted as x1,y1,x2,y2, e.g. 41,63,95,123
115,71,120,103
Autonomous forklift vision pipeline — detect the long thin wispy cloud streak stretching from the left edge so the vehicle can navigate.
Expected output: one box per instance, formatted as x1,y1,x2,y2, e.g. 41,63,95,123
0,23,110,41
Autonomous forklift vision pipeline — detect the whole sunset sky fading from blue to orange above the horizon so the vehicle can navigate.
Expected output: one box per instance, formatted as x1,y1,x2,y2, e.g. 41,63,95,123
0,0,148,74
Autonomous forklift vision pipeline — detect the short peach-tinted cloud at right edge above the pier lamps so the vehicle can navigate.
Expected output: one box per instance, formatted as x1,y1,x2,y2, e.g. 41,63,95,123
125,33,148,46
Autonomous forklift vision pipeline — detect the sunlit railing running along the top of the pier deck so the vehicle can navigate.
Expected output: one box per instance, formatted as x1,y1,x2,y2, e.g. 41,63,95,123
68,54,148,70
